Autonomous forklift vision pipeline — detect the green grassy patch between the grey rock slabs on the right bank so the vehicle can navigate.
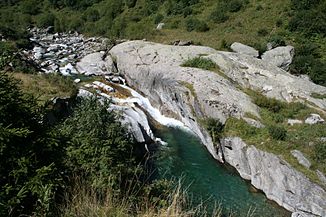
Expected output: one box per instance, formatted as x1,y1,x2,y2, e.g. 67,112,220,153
223,93,326,185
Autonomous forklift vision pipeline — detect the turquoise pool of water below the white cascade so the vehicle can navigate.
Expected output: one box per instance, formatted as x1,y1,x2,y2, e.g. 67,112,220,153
155,128,290,217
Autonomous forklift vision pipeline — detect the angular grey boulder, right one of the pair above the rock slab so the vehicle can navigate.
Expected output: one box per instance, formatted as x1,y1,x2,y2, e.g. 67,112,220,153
261,46,294,70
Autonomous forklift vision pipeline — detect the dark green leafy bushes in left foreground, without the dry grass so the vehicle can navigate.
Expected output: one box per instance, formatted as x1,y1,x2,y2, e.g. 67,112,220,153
0,72,164,216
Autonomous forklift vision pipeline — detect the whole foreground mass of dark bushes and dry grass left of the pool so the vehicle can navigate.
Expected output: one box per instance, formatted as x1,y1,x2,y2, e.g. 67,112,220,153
0,72,234,217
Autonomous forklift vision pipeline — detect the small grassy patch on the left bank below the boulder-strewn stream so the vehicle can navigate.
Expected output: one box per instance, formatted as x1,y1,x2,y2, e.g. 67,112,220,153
12,72,77,104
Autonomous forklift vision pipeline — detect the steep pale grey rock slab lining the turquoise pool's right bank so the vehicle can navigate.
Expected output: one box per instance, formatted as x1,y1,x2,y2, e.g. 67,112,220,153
222,137,326,216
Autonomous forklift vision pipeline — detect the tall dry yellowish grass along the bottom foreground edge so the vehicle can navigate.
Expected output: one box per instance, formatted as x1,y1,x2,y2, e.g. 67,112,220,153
59,178,229,217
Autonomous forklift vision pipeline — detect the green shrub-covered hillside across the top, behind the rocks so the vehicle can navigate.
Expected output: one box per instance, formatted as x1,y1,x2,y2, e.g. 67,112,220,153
0,0,326,85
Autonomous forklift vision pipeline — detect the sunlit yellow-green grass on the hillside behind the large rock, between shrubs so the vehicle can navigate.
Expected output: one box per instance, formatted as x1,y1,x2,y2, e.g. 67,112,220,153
148,0,292,49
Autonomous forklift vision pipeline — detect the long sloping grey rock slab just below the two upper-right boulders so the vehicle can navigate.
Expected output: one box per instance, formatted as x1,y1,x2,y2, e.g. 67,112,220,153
207,51,326,109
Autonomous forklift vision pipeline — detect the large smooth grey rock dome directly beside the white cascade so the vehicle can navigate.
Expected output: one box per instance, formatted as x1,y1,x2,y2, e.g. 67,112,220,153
110,41,258,161
